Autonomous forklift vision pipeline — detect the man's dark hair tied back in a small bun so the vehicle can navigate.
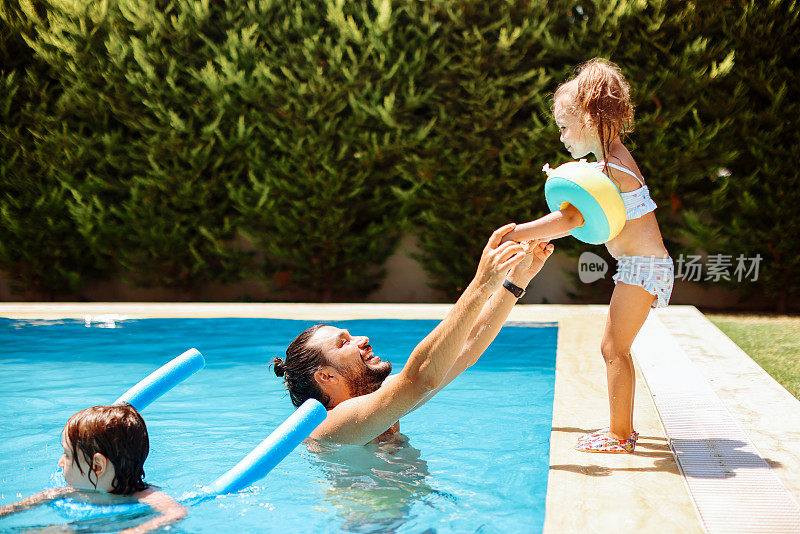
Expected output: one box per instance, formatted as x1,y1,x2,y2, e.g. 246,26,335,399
271,324,330,406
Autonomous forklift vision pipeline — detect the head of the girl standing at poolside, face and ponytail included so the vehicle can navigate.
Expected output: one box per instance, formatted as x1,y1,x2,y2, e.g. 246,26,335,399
553,58,633,160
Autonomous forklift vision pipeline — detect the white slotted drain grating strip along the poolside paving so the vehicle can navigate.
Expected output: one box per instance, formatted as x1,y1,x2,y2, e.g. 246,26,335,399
633,314,800,534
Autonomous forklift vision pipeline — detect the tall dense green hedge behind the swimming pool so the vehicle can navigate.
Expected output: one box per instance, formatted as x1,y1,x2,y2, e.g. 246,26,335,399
0,0,800,305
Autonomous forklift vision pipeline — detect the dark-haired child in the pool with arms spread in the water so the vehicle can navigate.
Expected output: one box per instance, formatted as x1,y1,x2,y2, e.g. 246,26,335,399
0,403,186,533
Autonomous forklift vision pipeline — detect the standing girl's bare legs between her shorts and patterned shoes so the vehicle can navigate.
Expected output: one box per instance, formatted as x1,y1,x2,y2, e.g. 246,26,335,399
600,282,655,440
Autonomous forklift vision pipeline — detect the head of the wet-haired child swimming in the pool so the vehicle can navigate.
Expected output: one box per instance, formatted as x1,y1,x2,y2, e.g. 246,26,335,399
58,404,150,495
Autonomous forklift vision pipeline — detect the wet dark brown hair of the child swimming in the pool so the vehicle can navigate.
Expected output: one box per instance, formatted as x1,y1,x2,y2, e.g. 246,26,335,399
64,403,150,495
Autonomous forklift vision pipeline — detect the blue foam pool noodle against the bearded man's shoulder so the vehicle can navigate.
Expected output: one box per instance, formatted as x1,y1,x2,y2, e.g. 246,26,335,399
205,399,328,495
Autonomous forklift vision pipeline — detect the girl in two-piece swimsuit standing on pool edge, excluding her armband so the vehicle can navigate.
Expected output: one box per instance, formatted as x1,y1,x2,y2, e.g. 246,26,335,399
505,58,674,453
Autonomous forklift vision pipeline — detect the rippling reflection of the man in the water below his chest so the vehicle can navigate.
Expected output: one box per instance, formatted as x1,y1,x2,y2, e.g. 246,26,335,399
307,433,456,533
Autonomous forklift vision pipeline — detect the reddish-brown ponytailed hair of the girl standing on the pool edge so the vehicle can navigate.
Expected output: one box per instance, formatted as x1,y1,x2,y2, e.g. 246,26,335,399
553,58,633,165
